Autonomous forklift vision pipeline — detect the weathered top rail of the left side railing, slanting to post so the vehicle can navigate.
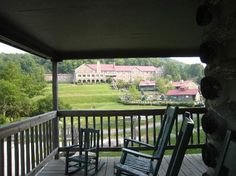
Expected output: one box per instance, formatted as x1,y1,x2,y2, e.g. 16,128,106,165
0,111,57,139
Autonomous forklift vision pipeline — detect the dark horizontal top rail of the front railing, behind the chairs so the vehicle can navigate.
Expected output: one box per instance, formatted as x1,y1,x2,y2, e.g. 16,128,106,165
57,108,206,117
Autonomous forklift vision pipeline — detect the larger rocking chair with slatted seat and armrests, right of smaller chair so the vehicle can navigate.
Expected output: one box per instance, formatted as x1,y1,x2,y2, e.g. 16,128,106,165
114,106,178,175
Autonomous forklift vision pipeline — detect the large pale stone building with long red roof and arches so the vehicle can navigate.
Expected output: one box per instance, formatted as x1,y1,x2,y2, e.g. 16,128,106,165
74,61,163,83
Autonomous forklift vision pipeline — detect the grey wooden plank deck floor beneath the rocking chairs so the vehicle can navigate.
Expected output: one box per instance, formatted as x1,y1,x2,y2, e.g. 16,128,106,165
37,154,207,176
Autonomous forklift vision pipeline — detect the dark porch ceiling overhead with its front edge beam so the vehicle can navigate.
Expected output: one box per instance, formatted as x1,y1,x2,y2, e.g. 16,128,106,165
0,0,202,60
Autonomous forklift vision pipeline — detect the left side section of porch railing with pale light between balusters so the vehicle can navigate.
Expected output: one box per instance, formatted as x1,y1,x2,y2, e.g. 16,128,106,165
0,111,58,176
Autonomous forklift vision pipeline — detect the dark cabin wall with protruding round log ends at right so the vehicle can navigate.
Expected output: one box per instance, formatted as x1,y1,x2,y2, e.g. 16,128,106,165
196,0,236,176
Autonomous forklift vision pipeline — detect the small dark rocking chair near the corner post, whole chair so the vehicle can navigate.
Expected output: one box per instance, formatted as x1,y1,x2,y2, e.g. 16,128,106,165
65,128,104,176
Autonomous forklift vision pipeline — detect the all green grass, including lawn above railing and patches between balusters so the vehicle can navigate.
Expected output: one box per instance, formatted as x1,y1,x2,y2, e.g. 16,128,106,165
41,84,204,156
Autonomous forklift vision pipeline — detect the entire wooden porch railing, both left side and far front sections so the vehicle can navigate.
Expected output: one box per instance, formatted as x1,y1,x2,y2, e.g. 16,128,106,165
0,108,206,176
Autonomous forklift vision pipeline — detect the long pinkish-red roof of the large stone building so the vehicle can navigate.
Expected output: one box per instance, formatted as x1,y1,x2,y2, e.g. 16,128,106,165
87,64,159,72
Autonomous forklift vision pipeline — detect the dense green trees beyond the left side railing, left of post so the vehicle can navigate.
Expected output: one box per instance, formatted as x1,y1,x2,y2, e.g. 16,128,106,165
0,54,46,121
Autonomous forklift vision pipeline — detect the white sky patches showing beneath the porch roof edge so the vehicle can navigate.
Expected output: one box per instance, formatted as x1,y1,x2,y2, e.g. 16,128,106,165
0,43,201,64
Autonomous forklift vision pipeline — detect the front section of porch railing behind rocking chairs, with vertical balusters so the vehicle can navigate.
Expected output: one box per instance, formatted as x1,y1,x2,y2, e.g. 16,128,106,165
58,108,206,151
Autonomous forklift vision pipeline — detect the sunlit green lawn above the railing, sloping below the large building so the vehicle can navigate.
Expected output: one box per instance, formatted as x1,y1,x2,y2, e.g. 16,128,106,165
45,84,164,110
